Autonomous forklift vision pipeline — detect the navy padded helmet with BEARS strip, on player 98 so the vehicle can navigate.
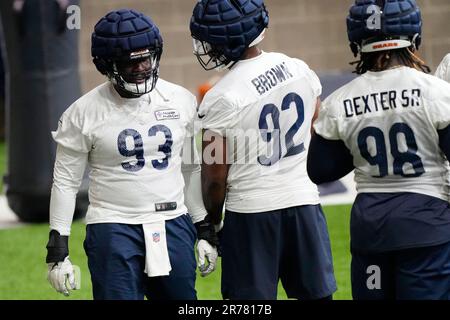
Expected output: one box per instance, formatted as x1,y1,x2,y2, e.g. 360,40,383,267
347,0,422,56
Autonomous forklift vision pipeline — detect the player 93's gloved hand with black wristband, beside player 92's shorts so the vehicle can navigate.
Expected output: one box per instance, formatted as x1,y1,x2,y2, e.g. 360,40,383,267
195,220,219,277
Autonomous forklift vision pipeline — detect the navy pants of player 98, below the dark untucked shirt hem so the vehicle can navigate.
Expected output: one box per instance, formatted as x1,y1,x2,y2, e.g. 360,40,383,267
351,243,450,300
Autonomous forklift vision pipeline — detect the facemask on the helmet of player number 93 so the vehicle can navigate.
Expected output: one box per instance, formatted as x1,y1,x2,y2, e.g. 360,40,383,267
108,49,161,97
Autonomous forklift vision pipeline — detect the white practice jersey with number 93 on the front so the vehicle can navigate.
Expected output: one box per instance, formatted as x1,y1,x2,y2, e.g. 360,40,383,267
53,79,197,224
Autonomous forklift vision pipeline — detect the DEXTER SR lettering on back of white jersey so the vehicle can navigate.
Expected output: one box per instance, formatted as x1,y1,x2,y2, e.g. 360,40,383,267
343,89,421,118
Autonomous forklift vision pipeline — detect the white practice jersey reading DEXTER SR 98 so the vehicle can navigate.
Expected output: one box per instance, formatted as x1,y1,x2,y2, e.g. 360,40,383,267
314,67,450,200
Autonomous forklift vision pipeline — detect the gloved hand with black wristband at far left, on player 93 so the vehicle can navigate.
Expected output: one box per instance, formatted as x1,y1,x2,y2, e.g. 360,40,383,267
45,230,76,296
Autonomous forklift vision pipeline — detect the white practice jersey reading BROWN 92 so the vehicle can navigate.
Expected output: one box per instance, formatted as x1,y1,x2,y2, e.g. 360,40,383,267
198,52,322,213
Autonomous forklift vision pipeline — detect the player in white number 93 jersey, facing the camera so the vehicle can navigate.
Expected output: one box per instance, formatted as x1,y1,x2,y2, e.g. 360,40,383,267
46,9,218,300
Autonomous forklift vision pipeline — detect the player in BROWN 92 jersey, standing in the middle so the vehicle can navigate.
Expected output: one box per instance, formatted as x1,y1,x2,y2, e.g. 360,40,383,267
190,0,336,299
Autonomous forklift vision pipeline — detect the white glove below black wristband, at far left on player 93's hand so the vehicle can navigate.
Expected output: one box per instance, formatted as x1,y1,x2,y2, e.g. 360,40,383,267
47,256,77,297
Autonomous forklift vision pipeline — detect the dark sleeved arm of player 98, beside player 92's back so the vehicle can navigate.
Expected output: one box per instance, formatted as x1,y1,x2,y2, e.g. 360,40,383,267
307,134,354,184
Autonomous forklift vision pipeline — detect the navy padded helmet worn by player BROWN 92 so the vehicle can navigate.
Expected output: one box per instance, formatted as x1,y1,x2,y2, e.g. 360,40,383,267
190,0,269,70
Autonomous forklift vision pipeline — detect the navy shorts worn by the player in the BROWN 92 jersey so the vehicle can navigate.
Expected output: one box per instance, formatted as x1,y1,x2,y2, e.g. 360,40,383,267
221,205,336,300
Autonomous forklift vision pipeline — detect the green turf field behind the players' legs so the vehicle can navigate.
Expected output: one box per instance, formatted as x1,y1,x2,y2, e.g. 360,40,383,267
0,206,351,300
